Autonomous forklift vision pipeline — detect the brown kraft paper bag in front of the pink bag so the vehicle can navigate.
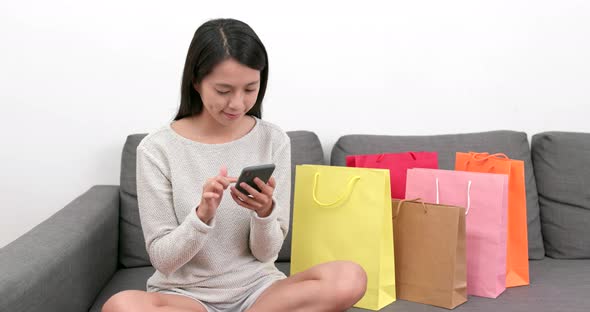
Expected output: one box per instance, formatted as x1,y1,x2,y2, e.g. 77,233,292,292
391,199,467,309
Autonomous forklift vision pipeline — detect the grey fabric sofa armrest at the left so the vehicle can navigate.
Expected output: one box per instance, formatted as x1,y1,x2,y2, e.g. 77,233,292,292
0,185,119,312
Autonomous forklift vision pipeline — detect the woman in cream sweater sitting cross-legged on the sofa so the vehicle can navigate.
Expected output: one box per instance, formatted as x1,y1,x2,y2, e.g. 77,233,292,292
103,19,366,312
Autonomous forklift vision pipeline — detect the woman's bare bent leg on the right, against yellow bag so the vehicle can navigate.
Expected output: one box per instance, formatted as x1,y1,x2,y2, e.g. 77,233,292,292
248,261,367,312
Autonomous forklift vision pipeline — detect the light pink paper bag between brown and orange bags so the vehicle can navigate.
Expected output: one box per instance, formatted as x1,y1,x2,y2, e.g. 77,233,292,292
406,169,508,298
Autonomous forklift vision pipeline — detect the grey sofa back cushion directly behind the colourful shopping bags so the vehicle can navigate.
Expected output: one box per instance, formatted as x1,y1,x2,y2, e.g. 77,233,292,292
331,131,545,259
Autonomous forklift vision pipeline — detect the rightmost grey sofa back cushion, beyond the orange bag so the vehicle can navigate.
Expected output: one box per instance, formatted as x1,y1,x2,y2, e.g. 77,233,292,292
532,132,590,259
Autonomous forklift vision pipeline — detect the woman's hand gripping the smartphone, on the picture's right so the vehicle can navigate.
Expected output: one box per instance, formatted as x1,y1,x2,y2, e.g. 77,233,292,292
230,177,276,218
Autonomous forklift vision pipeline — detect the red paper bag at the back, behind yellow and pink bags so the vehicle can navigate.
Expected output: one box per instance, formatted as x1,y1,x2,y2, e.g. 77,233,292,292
346,152,438,199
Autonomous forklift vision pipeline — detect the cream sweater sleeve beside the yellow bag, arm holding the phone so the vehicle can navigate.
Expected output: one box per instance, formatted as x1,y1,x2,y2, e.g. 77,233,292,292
250,134,291,262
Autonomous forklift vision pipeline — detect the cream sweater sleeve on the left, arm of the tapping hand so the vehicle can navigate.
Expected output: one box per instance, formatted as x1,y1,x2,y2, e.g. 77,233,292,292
136,145,215,275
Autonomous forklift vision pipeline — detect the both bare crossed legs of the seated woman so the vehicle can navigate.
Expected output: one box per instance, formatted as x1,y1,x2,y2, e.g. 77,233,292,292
102,261,367,312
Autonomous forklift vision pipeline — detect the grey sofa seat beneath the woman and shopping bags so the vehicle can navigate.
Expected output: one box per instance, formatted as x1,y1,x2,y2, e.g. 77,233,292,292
90,258,590,312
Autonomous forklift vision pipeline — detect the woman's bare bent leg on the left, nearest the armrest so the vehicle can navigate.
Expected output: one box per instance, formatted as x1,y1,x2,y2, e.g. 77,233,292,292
102,290,207,312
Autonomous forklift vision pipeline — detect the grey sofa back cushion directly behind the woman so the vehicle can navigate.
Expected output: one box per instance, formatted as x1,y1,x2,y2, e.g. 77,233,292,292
119,131,324,268
